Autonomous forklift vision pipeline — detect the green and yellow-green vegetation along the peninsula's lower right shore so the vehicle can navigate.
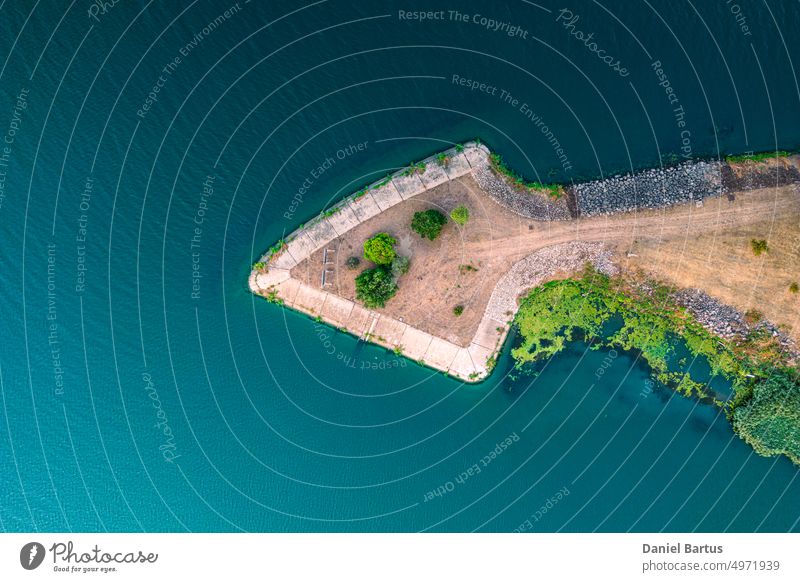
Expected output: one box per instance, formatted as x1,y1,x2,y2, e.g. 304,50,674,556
512,268,800,464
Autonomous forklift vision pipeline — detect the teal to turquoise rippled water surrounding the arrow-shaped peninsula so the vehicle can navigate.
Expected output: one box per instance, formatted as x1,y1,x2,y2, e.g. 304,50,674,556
0,1,800,531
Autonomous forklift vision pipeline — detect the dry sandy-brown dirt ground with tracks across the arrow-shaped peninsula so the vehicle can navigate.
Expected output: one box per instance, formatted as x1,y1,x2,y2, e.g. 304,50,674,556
292,175,800,346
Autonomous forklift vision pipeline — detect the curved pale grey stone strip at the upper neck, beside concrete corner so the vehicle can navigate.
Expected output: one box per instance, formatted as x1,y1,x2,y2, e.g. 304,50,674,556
472,164,572,220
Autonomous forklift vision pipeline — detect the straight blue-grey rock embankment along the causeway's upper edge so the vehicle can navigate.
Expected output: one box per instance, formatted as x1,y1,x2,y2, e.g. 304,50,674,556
570,162,725,216
